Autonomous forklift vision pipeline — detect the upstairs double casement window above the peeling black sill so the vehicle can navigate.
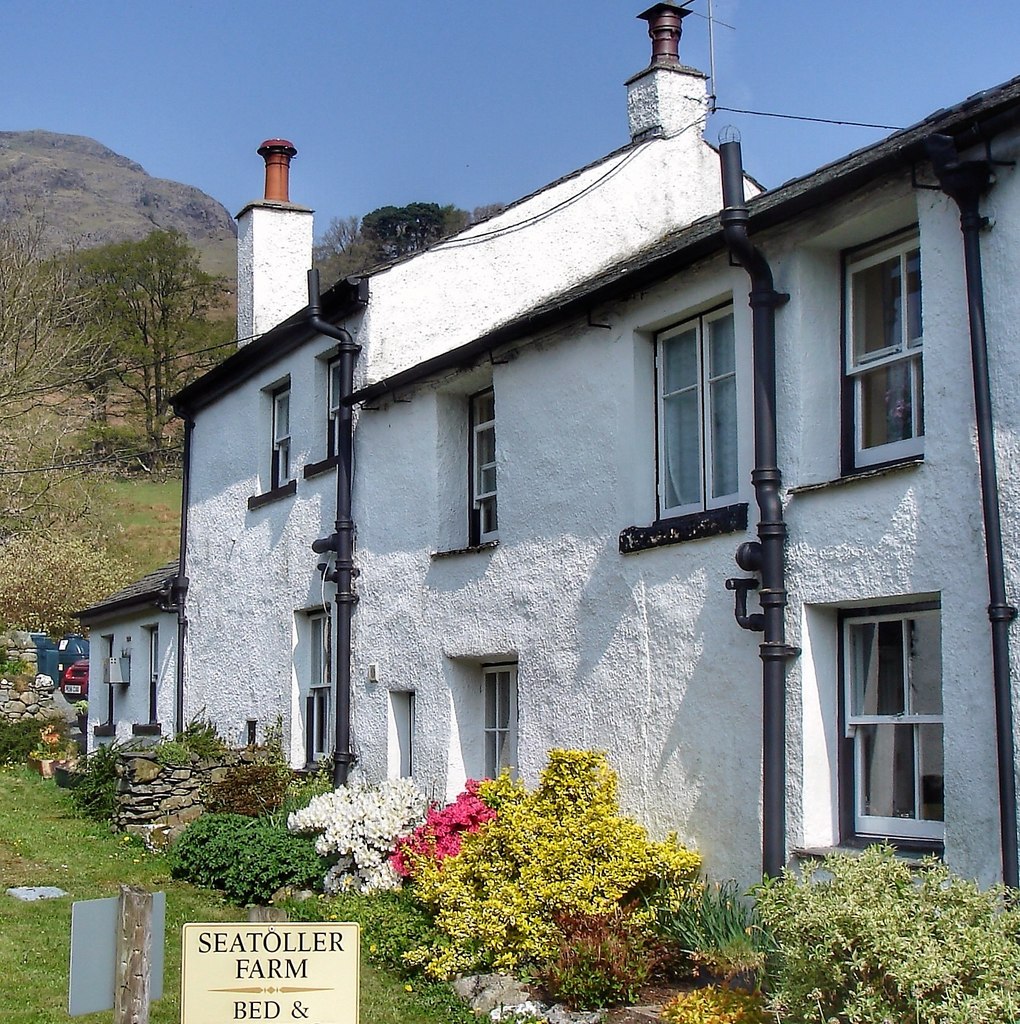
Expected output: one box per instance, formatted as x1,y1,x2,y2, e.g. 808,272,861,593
655,305,739,517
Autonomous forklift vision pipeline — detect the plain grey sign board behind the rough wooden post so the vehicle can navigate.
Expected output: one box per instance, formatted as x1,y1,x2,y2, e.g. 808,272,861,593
68,893,167,1017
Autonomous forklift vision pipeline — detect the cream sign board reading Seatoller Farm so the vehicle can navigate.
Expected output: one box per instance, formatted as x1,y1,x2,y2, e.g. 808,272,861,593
180,922,360,1024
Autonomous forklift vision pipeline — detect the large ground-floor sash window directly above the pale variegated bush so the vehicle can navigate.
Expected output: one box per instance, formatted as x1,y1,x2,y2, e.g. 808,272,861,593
841,604,944,842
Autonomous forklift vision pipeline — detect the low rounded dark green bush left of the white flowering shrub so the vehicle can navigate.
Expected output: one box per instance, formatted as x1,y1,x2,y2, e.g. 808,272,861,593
169,814,326,906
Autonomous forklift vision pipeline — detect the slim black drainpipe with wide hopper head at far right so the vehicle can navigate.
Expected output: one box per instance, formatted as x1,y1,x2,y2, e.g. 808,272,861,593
925,135,1018,889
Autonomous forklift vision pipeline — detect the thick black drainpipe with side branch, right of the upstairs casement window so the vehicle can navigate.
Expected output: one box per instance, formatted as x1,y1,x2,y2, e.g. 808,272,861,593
719,141,800,877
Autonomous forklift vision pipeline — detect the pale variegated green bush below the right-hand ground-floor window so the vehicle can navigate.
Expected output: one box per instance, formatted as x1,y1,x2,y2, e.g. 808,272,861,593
757,846,1020,1024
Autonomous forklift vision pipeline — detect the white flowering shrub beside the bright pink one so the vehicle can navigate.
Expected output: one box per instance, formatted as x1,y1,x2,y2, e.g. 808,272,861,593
287,778,428,894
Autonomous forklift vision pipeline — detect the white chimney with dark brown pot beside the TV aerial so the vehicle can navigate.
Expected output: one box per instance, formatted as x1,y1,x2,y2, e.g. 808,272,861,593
627,2,709,142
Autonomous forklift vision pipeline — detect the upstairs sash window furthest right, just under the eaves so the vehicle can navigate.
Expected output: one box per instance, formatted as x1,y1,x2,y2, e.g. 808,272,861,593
845,233,925,469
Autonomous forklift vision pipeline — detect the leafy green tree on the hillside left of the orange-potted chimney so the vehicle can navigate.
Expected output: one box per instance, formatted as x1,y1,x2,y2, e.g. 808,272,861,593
81,230,233,474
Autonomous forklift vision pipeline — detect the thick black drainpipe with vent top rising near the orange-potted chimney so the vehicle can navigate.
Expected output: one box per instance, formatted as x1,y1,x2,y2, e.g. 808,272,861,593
307,269,362,786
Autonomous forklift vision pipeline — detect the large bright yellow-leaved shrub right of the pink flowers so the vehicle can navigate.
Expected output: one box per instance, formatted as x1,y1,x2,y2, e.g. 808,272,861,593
406,751,700,978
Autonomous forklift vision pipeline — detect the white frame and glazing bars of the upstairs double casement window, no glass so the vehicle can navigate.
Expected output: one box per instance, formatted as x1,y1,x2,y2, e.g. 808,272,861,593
655,303,740,518
